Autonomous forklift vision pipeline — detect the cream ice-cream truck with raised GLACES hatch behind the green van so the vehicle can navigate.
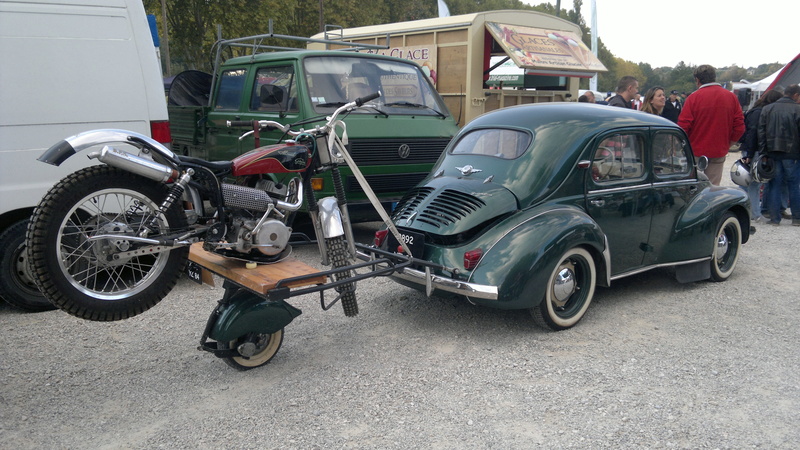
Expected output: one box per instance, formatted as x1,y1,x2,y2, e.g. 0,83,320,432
309,10,607,126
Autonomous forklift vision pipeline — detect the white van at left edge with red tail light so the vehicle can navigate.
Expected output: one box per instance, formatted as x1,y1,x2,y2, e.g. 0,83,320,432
0,0,170,311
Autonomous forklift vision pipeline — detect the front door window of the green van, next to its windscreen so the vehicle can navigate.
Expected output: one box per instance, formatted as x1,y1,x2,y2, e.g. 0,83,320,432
250,66,297,112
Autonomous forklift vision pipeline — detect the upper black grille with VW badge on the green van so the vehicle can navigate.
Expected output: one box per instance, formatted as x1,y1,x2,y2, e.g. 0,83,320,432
350,138,450,166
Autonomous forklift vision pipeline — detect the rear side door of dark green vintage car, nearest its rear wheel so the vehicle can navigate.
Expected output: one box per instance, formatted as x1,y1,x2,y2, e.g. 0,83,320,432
586,130,653,276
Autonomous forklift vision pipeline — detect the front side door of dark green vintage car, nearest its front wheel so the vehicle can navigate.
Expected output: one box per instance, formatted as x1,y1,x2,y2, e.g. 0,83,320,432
644,130,699,265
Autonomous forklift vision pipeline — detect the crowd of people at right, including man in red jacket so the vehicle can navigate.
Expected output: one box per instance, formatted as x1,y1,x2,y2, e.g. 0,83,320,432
578,64,800,226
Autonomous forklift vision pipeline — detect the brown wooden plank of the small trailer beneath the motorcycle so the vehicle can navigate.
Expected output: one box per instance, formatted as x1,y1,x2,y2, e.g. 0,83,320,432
189,242,326,294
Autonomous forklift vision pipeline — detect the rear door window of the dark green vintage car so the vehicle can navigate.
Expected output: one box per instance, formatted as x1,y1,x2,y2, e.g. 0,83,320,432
592,134,644,184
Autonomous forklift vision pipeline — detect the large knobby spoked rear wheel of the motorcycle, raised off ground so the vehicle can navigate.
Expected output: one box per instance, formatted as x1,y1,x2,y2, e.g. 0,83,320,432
26,166,189,321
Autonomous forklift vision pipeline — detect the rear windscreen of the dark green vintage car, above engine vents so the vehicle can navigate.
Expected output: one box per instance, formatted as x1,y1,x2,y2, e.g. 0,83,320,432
450,128,532,159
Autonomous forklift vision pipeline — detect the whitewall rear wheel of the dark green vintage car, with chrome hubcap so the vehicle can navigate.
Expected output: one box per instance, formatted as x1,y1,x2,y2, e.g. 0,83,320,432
531,247,597,331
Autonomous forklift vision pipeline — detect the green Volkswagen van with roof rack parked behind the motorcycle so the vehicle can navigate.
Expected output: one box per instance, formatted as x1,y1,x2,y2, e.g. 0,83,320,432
168,50,458,221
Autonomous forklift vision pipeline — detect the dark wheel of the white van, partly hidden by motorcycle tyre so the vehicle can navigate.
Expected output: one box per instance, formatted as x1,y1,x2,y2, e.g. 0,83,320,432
0,219,56,312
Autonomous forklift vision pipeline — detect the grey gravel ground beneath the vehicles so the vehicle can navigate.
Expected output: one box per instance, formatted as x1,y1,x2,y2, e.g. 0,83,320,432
0,154,800,449
